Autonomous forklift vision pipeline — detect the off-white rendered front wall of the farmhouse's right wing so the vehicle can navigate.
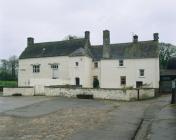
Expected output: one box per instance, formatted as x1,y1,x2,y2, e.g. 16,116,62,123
100,58,159,88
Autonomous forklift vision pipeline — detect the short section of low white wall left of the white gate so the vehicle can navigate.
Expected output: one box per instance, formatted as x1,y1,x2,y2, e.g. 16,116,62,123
3,87,34,96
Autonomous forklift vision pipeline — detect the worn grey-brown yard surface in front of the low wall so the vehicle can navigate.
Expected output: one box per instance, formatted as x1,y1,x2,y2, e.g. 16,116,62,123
0,96,176,140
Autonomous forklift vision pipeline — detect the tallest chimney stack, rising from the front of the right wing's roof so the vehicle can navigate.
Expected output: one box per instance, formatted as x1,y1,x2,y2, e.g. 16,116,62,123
103,30,110,58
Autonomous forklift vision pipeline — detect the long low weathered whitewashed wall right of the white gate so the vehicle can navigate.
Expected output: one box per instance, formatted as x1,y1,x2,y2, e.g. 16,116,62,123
45,87,155,101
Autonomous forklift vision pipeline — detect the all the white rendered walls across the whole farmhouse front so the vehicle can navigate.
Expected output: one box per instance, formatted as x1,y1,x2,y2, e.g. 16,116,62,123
18,56,159,88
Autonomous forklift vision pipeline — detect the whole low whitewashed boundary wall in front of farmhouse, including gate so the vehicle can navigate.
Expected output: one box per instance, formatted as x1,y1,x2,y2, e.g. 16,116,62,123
3,87,155,101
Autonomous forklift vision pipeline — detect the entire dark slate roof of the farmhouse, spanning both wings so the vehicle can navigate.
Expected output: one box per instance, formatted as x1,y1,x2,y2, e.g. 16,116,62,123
20,38,159,61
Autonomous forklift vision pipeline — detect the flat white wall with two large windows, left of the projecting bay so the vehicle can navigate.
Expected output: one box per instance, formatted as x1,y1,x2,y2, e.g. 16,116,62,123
18,56,70,86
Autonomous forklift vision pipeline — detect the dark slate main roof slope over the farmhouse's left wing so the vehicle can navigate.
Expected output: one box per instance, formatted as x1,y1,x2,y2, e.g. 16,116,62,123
19,38,86,59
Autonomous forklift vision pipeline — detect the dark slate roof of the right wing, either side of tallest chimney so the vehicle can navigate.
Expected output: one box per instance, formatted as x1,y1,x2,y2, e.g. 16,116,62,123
91,40,159,60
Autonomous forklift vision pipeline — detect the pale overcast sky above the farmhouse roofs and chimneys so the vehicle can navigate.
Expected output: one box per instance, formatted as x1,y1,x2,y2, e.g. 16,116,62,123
0,0,176,59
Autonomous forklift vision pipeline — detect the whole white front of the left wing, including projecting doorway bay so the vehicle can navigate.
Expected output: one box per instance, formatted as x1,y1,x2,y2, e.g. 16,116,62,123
18,56,92,88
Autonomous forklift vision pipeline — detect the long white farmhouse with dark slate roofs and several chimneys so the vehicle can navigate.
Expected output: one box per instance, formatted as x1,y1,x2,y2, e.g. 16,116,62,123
18,30,159,88
